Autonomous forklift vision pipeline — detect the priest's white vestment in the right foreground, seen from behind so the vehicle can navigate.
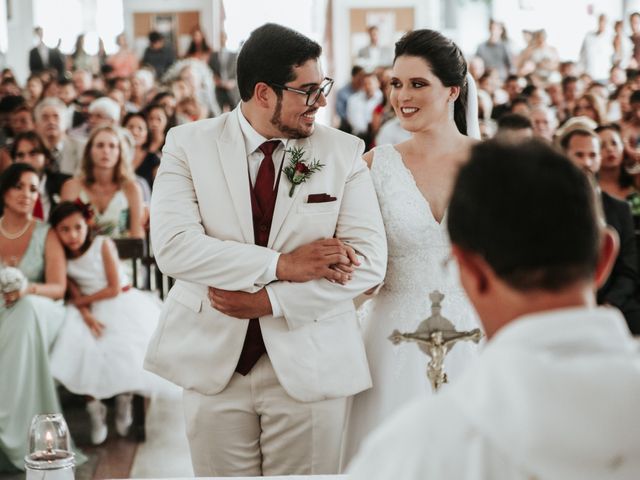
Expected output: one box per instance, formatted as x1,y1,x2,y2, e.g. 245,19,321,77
349,308,640,480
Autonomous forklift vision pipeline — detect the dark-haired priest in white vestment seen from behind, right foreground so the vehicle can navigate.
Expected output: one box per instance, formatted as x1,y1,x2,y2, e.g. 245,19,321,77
350,140,640,480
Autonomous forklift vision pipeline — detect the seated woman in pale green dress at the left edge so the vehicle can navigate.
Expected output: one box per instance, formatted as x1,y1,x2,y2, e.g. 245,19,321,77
0,163,66,472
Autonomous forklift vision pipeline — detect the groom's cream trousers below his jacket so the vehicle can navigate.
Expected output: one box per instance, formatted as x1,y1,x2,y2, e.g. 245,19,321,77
183,355,347,477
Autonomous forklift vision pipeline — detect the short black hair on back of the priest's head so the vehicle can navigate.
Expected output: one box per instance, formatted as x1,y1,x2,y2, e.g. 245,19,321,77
447,140,604,291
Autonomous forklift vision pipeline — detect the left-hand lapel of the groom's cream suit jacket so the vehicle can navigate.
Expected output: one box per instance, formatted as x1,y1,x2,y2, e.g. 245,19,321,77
217,112,254,243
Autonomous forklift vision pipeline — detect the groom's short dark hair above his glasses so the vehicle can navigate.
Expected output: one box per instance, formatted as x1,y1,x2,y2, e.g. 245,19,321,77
237,23,322,102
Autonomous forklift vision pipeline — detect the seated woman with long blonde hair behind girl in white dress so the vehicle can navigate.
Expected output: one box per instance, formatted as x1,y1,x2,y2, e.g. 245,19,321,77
61,126,144,238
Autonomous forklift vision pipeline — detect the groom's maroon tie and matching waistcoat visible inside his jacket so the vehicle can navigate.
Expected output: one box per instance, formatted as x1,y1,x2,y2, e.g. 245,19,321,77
236,140,280,375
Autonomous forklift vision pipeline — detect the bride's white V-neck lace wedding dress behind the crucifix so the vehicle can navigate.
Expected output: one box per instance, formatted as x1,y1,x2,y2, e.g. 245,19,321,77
342,145,480,467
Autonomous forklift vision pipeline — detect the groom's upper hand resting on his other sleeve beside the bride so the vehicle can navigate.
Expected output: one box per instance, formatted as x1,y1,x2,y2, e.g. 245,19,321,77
276,238,360,284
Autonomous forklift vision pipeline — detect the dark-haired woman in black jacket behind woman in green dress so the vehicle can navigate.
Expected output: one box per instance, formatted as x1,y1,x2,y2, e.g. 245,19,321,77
11,132,71,221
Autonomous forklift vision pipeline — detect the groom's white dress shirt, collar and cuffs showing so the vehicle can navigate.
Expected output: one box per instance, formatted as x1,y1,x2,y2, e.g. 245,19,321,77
236,108,287,317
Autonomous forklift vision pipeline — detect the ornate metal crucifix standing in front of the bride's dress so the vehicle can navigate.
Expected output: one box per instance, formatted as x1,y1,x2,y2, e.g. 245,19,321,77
389,290,482,392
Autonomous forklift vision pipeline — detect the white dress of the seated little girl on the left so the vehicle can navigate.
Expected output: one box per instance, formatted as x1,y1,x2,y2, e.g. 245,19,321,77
51,236,163,399
